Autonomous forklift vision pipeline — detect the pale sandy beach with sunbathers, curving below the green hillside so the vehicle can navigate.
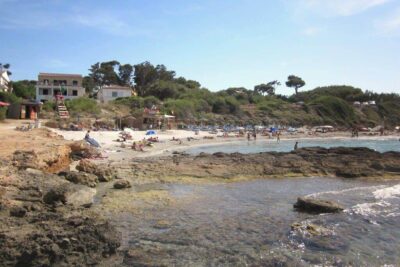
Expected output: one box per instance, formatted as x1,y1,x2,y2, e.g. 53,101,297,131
51,126,400,162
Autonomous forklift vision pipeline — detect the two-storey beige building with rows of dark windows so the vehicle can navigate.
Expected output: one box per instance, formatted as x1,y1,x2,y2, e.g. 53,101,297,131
36,73,85,102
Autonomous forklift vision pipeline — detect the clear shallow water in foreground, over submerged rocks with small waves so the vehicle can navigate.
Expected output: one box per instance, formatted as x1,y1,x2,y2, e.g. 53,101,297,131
113,178,400,266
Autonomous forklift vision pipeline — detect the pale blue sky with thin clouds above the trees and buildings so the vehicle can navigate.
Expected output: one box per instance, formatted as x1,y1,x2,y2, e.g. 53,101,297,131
0,0,400,94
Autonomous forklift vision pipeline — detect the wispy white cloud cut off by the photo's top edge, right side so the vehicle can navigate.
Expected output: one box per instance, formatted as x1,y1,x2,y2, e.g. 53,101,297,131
298,0,392,16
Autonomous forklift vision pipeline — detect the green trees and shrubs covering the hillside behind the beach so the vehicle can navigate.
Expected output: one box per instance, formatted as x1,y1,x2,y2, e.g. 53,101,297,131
0,60,400,128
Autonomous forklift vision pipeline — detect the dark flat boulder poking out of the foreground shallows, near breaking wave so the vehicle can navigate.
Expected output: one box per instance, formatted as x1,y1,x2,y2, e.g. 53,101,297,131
294,197,344,214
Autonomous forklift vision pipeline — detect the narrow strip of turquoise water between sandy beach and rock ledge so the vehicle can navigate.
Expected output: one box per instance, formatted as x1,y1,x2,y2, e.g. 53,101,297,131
186,139,400,155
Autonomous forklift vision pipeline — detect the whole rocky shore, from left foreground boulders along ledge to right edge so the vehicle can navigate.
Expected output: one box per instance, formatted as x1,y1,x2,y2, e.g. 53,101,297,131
0,135,400,266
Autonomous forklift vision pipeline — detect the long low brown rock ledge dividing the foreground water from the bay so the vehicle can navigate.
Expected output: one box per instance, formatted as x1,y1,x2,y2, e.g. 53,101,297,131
132,147,400,182
